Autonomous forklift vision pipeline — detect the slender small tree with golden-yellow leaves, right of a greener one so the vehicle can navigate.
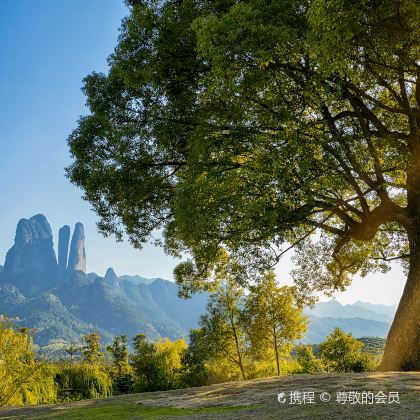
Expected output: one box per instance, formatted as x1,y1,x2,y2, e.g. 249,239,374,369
244,272,306,375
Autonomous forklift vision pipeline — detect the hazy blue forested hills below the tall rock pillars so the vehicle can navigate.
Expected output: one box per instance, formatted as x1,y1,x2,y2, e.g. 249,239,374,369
0,273,207,345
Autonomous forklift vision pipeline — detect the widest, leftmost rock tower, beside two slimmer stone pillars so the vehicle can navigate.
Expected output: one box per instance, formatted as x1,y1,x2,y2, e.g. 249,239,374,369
4,214,57,287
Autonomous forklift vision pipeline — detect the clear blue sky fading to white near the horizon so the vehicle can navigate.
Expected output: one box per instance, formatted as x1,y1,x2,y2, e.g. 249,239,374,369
0,0,405,303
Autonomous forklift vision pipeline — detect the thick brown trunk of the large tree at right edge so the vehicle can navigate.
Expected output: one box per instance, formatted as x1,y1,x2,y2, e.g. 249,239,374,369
379,223,420,371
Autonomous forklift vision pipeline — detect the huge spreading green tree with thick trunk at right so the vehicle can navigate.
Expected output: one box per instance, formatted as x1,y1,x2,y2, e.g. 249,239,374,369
68,0,420,370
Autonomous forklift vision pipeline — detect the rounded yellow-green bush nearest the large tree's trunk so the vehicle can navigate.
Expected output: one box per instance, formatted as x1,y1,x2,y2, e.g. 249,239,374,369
320,328,375,372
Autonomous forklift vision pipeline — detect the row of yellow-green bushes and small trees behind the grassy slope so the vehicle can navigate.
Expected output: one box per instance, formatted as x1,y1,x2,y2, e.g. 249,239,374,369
0,316,375,405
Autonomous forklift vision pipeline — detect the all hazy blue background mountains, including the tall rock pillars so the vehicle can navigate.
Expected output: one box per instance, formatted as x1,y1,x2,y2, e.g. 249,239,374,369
0,214,396,345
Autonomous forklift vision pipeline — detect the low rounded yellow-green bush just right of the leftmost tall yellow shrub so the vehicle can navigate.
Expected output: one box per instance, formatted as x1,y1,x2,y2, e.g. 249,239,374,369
55,363,112,400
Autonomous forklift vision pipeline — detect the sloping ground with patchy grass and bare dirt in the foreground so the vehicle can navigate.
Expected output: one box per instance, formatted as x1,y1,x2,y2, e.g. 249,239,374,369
0,372,420,420
